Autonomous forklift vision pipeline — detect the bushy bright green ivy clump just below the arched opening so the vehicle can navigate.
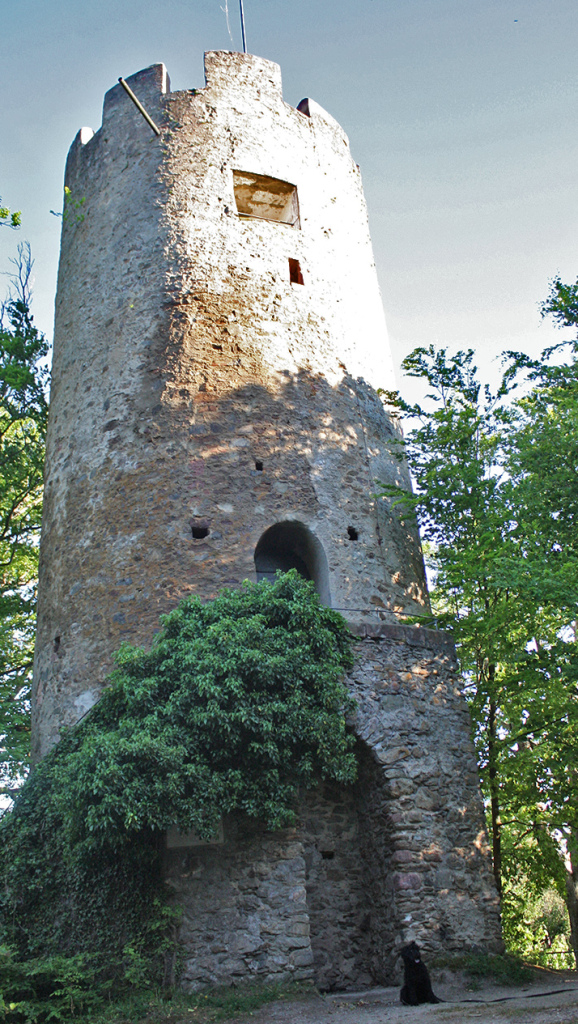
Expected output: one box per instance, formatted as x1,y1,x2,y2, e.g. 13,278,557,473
58,572,356,848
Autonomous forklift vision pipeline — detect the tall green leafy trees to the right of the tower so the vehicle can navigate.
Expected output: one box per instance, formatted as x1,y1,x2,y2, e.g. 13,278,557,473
379,281,578,954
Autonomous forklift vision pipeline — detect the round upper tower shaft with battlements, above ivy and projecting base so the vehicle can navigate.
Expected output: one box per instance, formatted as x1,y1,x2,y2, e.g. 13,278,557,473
34,52,426,758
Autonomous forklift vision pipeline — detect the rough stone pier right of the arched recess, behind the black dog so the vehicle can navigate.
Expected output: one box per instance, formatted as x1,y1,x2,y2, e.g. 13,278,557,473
349,625,502,981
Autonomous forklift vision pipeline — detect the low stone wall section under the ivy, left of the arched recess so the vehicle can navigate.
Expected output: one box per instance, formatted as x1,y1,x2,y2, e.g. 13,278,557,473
166,815,313,991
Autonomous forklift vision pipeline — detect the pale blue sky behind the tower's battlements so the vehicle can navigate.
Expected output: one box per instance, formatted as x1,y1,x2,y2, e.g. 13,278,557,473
0,0,578,393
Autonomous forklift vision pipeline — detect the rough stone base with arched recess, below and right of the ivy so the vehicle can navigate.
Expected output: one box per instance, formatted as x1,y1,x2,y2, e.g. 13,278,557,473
169,625,502,989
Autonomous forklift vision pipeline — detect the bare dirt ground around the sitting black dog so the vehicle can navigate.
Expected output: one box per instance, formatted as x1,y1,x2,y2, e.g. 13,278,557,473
232,972,578,1024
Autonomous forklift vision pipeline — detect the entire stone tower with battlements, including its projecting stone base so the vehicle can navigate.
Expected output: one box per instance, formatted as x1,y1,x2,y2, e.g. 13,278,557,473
34,52,499,987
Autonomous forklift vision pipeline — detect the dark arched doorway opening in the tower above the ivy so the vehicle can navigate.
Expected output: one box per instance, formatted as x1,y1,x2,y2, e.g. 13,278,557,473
255,521,331,605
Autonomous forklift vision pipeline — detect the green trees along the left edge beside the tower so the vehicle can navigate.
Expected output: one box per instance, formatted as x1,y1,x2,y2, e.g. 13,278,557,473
0,300,48,782
